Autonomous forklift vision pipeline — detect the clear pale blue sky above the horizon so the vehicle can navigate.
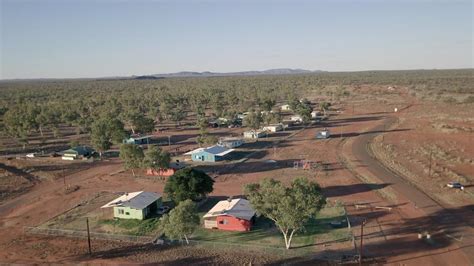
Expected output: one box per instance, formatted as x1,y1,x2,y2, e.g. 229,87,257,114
0,0,474,79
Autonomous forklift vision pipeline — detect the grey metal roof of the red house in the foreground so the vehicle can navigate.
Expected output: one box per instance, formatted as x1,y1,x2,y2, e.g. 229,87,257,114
204,199,255,221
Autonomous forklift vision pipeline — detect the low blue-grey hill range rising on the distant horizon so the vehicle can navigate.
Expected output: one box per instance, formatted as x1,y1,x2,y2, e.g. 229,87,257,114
147,68,323,78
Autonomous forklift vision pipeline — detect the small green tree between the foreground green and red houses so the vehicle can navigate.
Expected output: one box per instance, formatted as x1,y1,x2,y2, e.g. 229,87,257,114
160,200,200,244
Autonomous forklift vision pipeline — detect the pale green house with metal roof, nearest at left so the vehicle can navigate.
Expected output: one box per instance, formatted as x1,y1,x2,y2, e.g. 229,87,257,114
101,191,161,220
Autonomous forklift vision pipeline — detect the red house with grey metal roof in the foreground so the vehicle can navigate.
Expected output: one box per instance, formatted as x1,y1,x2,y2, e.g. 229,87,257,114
204,199,255,232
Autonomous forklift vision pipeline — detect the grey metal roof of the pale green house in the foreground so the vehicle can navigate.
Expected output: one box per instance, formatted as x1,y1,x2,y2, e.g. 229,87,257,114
101,191,161,210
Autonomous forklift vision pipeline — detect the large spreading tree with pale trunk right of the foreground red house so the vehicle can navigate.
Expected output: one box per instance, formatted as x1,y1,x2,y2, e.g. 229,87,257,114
244,178,326,249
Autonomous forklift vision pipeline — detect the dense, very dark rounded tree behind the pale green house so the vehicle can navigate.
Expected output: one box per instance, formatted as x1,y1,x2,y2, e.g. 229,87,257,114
164,168,214,202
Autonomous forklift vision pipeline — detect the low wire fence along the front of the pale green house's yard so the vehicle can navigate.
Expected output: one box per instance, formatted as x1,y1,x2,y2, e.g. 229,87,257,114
24,226,155,243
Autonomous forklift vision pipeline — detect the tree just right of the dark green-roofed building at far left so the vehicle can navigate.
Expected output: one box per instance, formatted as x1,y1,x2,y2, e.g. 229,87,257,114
91,117,126,157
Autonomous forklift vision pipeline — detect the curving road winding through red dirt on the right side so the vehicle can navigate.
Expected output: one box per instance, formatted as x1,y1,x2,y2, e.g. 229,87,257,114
352,113,474,265
